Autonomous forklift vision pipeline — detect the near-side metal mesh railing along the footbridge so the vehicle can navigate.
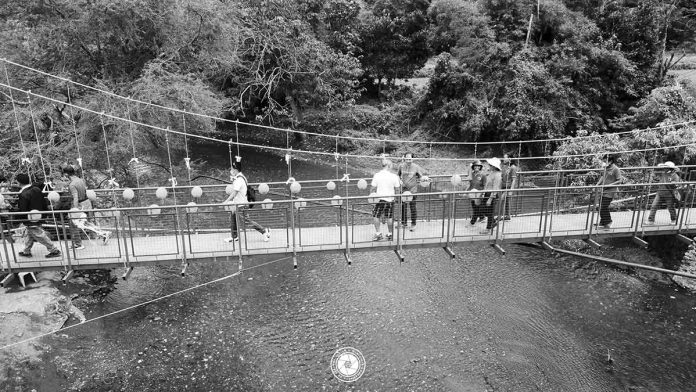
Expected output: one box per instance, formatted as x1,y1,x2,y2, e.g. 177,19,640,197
0,182,696,270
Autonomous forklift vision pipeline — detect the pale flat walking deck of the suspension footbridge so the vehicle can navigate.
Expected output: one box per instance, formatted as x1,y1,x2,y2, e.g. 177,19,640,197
0,208,696,272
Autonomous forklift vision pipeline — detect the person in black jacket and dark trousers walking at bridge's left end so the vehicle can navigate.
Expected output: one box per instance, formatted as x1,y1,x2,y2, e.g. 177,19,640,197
16,173,60,257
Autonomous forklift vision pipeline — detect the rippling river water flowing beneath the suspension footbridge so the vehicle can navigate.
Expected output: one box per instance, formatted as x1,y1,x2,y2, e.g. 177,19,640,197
19,149,696,391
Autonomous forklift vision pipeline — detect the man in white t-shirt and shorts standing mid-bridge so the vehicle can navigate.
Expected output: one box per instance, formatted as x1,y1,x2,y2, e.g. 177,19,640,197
372,159,401,241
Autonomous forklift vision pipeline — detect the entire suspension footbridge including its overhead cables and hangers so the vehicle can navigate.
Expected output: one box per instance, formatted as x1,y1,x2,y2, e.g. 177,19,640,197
0,59,696,279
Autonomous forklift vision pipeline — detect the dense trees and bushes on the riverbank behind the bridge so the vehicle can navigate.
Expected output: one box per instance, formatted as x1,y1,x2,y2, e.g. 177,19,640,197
0,0,696,183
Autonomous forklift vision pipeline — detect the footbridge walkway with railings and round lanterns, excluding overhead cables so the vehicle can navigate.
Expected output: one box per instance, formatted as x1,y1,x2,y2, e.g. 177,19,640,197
0,168,696,277
